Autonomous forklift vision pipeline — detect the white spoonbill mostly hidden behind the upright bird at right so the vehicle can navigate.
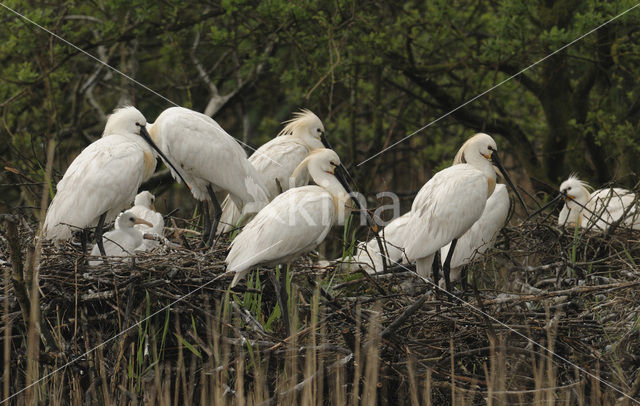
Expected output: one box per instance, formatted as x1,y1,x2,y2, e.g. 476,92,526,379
440,184,510,288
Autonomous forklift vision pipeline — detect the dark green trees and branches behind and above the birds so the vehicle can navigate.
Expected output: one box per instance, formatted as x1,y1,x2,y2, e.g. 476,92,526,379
0,0,640,219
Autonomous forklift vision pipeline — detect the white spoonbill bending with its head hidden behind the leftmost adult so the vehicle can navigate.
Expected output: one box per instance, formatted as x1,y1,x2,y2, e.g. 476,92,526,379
148,107,269,243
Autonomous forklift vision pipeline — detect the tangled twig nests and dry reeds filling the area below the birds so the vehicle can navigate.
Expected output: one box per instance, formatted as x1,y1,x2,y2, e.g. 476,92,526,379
0,214,640,405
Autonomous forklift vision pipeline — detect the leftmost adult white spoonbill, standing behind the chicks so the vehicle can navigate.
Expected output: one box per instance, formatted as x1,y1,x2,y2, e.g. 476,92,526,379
42,106,185,254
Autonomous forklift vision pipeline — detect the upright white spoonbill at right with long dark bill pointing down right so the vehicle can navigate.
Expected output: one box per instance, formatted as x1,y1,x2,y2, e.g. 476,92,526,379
404,133,526,291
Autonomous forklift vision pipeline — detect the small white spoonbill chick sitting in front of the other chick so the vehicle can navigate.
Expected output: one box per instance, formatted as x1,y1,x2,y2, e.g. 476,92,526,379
89,210,153,266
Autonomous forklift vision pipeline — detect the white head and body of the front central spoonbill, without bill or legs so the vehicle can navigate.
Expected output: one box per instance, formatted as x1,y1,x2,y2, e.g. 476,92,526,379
225,149,348,286
